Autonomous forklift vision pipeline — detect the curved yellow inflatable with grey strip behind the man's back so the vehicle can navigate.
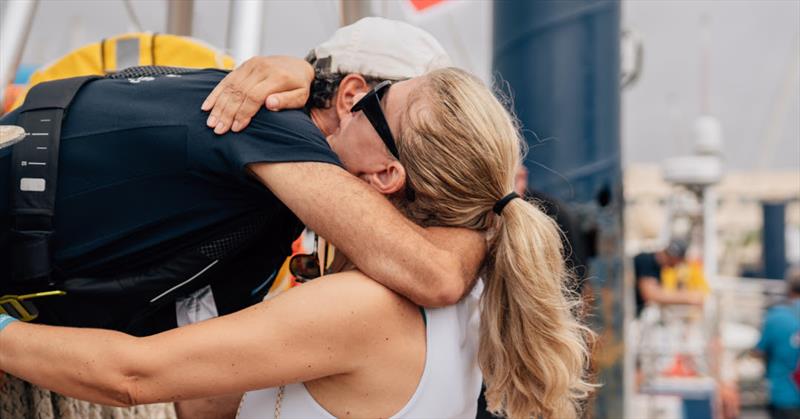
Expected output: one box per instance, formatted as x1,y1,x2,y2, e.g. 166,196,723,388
7,33,235,111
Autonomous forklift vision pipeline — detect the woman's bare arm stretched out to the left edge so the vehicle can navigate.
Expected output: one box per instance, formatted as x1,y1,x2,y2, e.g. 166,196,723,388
0,272,400,406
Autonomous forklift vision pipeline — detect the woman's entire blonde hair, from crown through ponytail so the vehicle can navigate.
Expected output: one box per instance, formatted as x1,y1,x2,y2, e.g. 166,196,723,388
398,68,593,418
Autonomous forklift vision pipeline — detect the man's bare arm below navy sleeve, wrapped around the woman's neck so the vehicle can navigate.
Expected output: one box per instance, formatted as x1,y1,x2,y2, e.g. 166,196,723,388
253,163,485,306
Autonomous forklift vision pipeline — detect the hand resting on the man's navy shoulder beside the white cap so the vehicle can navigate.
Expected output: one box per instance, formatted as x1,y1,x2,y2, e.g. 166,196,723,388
201,56,314,134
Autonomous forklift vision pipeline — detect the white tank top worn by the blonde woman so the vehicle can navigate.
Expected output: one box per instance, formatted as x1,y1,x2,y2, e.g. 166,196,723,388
237,280,483,419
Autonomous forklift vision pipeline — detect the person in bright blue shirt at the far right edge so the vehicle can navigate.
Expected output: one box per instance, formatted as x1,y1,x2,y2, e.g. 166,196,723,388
756,269,800,417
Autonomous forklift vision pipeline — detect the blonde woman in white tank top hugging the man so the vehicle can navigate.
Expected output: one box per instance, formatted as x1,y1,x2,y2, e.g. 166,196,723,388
0,69,592,418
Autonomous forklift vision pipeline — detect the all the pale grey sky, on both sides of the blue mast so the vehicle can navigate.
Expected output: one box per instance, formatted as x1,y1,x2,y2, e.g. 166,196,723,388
0,0,800,170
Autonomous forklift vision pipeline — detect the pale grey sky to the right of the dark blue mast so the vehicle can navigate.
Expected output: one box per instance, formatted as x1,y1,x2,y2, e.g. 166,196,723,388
622,0,800,170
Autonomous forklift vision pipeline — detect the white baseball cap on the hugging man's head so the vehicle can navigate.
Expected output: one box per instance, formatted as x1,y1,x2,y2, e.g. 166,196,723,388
309,17,451,80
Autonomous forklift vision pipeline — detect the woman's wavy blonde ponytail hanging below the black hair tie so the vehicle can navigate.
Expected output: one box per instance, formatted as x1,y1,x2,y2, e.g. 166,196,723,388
478,199,592,418
